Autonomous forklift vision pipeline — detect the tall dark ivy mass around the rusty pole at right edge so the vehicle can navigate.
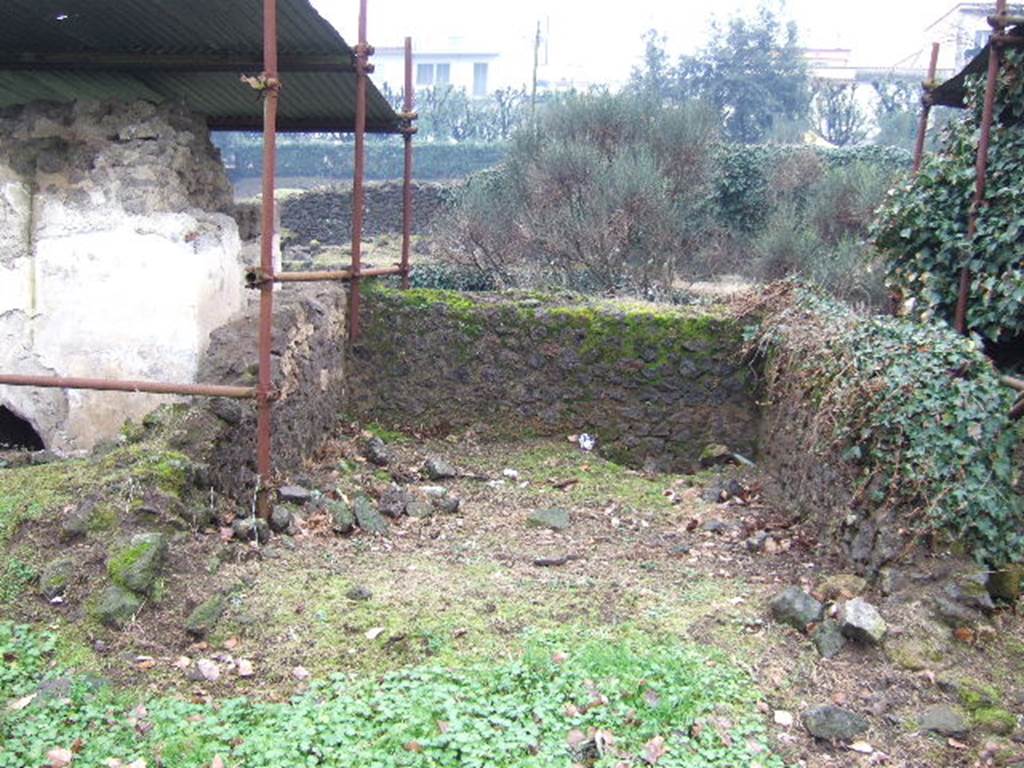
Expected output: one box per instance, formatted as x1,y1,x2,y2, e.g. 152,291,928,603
872,49,1024,341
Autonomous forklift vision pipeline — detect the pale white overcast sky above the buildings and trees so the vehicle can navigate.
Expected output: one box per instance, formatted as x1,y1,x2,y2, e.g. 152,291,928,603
313,0,953,87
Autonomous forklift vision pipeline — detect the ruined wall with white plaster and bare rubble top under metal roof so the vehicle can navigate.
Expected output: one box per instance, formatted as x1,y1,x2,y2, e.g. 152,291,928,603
0,101,244,451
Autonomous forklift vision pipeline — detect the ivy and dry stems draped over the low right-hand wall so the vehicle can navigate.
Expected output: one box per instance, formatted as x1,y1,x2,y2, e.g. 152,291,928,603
760,288,1024,566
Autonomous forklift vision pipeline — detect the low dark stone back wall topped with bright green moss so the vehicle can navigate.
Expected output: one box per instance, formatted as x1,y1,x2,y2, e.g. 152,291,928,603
347,286,758,470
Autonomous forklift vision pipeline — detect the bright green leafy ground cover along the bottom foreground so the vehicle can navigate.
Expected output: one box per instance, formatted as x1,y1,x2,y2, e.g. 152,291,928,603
0,624,782,768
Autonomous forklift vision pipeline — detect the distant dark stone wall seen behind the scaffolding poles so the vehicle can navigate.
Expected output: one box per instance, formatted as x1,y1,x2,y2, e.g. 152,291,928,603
281,181,453,248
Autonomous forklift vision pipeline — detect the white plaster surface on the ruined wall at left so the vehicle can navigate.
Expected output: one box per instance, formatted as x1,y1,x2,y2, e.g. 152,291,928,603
0,100,246,453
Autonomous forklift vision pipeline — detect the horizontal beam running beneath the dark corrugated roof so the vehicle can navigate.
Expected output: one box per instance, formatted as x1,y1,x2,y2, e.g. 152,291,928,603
0,51,355,73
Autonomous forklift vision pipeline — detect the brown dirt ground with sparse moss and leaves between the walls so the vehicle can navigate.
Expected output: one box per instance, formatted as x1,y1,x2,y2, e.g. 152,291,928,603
9,427,1024,768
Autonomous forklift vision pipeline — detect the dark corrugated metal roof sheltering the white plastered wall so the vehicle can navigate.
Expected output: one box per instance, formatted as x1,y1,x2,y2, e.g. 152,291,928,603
0,0,400,132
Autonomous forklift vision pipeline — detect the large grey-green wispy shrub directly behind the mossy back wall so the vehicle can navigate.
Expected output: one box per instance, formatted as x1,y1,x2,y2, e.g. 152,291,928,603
447,94,714,292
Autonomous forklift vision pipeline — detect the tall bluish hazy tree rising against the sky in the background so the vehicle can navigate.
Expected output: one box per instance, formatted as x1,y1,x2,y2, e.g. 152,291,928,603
677,6,809,143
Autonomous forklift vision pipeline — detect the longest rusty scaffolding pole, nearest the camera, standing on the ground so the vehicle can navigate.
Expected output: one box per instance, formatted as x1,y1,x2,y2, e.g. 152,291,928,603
256,0,280,518
